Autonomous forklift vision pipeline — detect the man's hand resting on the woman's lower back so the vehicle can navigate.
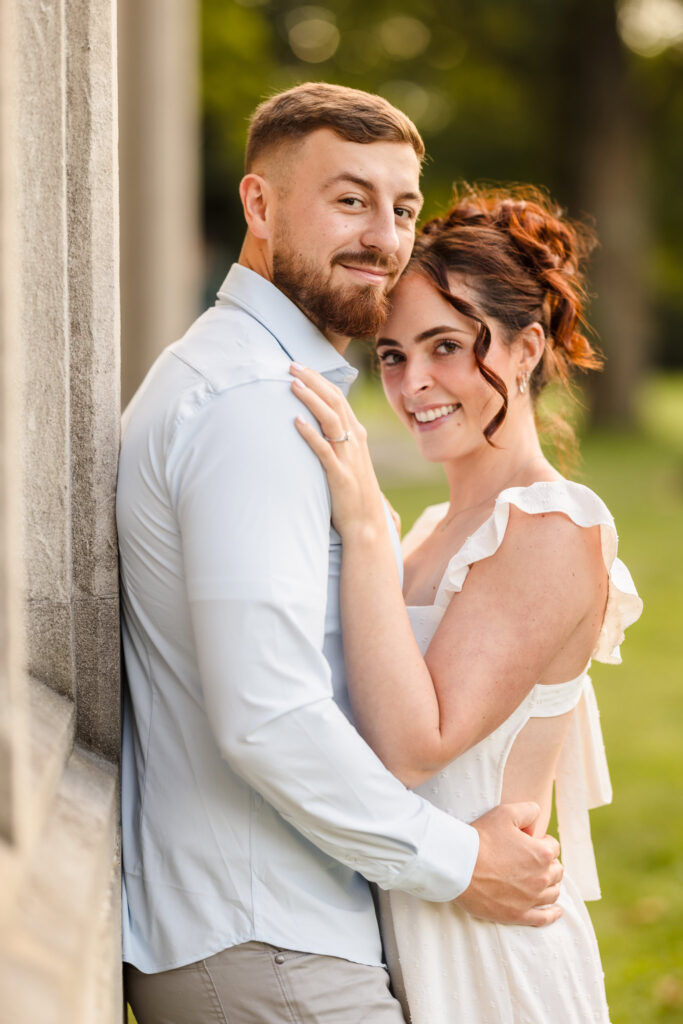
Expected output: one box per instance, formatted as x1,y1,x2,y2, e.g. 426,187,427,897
457,803,563,927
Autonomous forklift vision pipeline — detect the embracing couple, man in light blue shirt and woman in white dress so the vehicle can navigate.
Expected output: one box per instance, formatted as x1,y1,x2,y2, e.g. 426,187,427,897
117,83,640,1024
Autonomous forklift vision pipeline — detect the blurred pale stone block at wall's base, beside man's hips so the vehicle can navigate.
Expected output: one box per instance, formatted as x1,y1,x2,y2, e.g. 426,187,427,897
0,748,121,1024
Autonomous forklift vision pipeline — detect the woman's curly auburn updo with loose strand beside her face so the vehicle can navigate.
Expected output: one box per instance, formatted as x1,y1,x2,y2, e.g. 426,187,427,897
408,185,602,440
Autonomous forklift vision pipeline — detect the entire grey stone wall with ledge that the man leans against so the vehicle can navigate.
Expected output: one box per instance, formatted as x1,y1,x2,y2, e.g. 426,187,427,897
0,0,122,1024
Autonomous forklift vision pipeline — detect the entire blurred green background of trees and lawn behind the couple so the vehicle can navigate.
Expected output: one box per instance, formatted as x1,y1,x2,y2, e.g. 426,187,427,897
188,0,683,1024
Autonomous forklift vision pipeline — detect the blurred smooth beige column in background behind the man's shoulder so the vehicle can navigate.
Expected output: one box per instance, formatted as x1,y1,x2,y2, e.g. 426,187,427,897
119,0,200,406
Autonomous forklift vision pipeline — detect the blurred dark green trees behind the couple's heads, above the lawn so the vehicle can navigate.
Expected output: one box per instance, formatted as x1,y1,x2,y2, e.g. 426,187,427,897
202,0,683,426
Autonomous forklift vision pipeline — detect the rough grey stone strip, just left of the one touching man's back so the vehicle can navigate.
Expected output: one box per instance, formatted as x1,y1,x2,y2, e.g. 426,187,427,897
16,0,76,698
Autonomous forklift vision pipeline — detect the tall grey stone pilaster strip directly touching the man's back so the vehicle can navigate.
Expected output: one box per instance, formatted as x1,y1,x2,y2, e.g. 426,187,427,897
67,0,121,760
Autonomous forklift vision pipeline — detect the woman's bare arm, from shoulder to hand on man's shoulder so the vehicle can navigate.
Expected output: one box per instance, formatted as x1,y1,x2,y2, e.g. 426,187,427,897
294,370,606,785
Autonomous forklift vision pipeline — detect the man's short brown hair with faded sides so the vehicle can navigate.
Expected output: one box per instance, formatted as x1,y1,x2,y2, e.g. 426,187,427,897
245,82,425,173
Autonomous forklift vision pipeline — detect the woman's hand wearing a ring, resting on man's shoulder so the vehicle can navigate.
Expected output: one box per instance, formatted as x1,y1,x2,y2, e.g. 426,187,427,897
290,362,386,538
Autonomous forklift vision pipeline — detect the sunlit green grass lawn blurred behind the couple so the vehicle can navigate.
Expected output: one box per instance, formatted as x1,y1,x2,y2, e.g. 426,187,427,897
130,376,683,1024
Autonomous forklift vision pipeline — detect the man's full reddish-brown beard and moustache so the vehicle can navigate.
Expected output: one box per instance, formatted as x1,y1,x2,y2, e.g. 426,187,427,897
272,246,398,338
